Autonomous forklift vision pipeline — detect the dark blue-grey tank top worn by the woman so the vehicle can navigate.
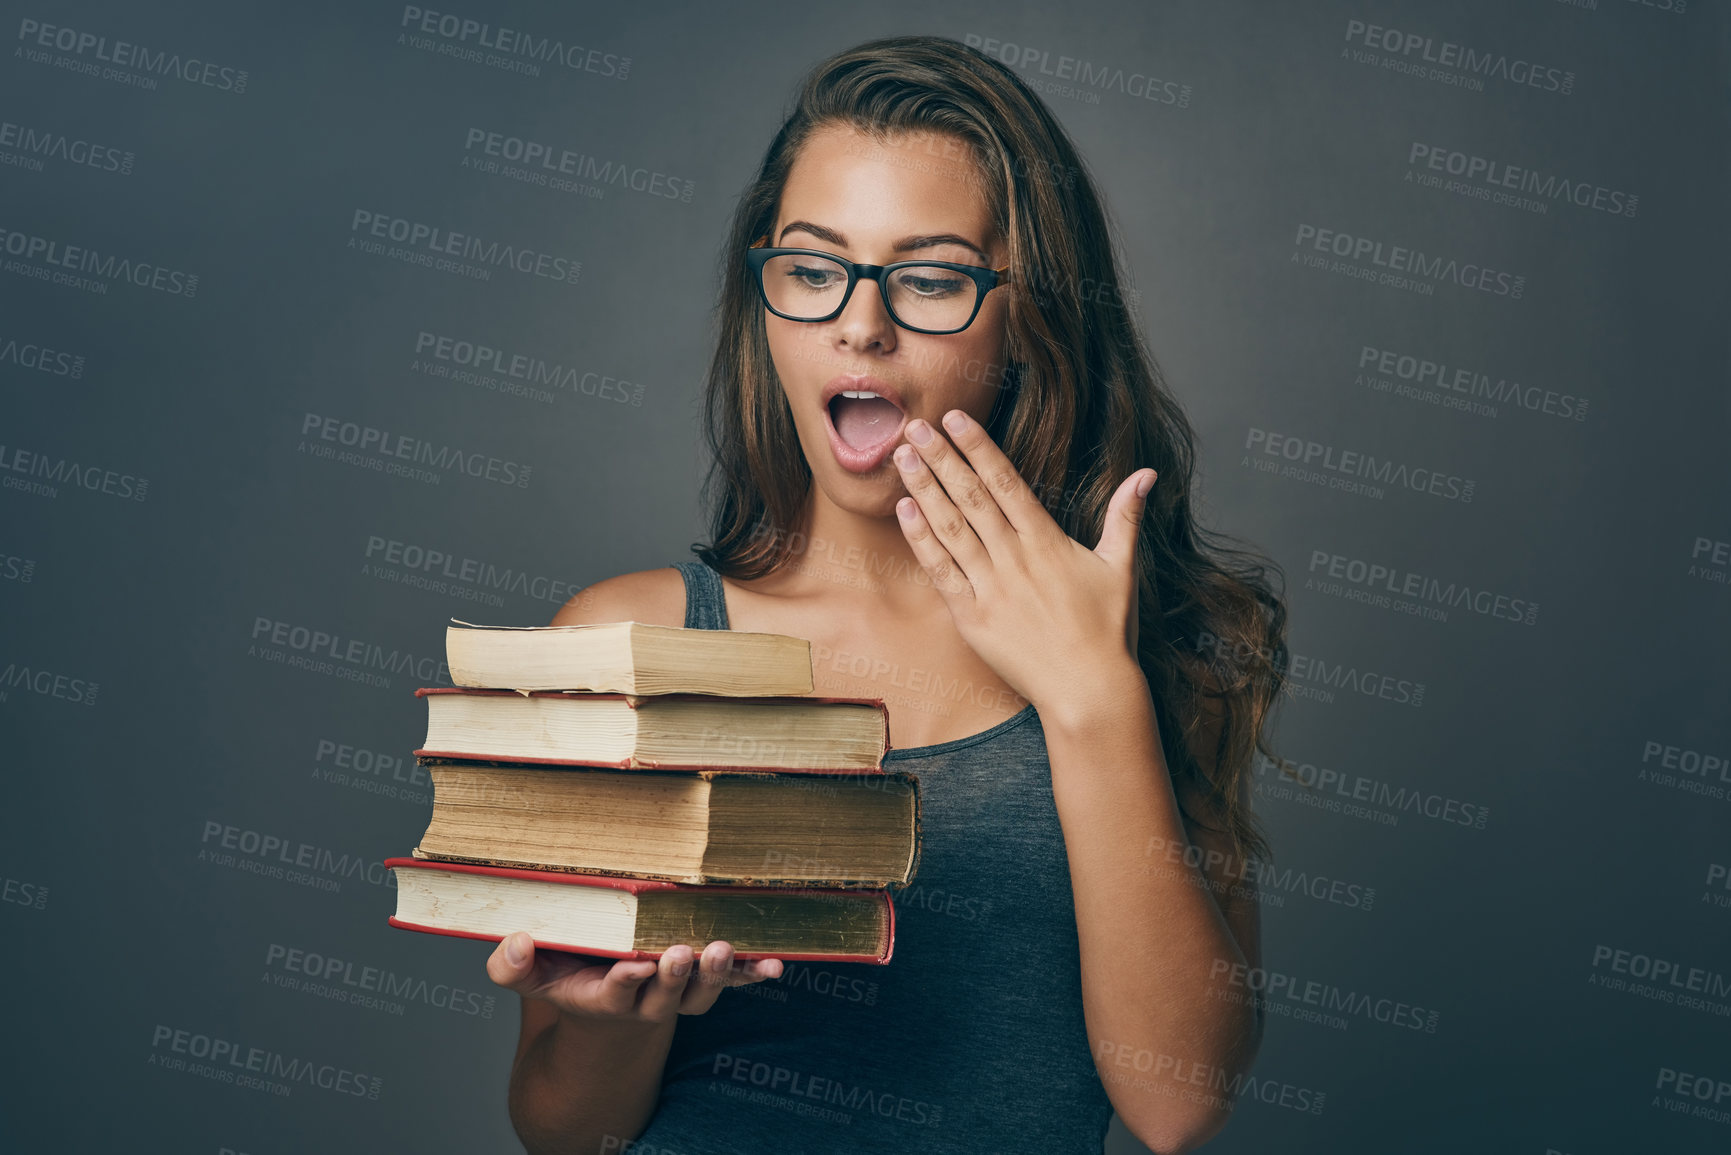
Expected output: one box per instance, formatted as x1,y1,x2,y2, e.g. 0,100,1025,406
621,561,1111,1155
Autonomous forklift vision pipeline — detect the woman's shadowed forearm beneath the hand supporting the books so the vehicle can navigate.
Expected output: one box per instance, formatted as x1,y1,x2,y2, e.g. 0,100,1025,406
507,1011,677,1155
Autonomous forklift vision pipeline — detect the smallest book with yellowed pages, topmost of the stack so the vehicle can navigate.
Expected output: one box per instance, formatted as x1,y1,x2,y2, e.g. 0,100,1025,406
445,618,812,698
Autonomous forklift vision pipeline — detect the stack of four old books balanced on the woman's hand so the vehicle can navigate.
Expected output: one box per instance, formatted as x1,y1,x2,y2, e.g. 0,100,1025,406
384,622,919,963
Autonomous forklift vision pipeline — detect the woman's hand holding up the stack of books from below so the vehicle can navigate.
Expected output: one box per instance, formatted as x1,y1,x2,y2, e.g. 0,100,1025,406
486,930,782,1023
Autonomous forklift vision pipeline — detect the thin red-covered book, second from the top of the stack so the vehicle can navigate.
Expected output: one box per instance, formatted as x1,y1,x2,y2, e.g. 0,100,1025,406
415,692,890,774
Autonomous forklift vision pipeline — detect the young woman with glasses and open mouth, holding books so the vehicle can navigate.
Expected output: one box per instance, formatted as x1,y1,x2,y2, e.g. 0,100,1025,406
488,36,1286,1155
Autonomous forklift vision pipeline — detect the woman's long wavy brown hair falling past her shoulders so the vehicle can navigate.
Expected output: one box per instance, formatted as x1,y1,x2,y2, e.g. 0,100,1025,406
692,36,1288,859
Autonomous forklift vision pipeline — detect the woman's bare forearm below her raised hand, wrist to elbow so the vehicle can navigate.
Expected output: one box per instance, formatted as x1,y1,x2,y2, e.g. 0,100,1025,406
1040,665,1260,1152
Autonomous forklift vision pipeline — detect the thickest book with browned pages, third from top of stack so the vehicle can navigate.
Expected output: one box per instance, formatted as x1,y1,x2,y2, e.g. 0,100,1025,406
414,758,919,888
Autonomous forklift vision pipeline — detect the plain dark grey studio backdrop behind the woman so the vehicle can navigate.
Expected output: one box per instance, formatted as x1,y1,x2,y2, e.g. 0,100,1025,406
0,0,1731,1155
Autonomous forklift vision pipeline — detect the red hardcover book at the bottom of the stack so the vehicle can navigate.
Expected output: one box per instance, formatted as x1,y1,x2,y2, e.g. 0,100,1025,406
384,857,895,965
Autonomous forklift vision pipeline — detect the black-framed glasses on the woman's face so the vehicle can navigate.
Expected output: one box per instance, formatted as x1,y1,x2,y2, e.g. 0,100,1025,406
746,236,1009,334
